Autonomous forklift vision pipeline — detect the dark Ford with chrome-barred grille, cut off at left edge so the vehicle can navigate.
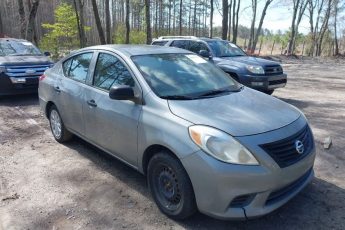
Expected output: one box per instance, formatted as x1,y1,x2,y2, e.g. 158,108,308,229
0,38,53,96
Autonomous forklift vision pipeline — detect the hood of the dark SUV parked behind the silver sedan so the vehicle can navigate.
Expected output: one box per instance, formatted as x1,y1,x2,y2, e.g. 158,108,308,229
214,56,280,66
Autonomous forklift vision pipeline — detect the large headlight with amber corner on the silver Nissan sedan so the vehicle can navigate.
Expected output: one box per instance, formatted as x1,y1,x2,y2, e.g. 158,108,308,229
189,125,259,165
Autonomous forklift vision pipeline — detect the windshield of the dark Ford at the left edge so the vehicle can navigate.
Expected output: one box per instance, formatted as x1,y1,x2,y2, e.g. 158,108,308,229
0,40,42,56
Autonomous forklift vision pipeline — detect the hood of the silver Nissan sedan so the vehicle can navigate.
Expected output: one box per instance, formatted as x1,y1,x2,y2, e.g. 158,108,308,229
168,87,301,136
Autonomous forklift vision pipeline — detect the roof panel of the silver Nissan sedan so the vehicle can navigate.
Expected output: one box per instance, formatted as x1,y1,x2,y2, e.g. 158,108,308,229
80,45,192,57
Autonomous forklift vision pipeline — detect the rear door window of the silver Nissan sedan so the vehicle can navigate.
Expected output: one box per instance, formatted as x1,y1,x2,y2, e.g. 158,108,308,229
62,53,92,83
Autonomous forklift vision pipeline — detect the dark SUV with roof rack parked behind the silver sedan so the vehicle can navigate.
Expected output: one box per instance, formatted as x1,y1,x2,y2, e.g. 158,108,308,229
152,36,287,94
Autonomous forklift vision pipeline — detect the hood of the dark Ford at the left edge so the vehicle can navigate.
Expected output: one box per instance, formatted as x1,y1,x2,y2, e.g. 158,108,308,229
0,56,52,65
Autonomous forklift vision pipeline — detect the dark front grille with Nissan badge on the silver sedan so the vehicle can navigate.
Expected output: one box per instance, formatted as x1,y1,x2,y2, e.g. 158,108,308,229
260,125,314,168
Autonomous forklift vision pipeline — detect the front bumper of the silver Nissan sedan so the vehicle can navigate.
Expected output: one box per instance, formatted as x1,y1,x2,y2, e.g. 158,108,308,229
181,119,315,219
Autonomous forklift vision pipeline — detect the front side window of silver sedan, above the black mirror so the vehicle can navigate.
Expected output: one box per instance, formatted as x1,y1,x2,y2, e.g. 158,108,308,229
93,53,134,90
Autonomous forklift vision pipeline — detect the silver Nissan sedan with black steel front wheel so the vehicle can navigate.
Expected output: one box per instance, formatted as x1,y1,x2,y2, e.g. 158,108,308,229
39,45,315,219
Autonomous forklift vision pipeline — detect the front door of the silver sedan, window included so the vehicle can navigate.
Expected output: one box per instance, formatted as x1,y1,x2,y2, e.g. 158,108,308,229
84,52,142,166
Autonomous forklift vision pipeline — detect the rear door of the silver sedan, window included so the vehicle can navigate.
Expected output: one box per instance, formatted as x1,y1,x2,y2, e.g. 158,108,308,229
54,52,93,135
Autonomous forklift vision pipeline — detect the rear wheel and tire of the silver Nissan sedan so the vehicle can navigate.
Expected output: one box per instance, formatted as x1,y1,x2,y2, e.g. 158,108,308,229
49,105,73,143
